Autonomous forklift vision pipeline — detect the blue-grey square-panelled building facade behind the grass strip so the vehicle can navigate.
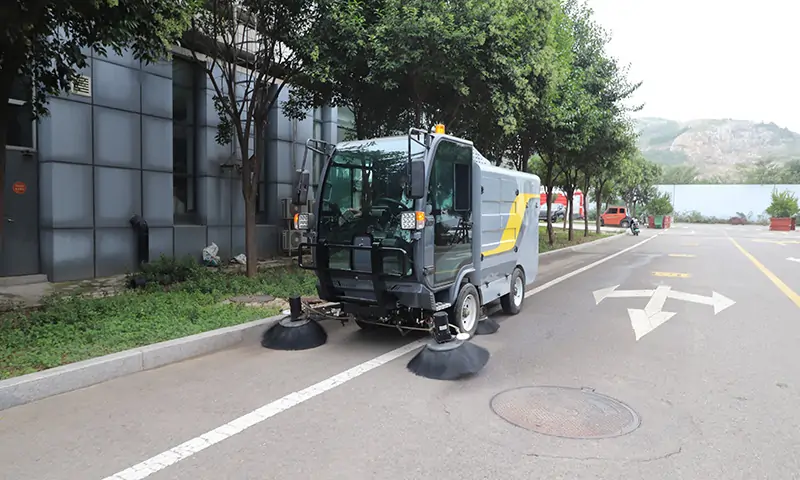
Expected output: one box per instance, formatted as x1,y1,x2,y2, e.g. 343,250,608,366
0,46,352,282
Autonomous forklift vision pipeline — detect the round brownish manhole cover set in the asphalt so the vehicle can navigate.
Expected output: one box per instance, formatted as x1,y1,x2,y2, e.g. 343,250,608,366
491,387,640,439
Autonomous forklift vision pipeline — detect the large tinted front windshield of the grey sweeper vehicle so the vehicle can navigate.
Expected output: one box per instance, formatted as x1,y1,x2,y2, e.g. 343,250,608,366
318,137,423,274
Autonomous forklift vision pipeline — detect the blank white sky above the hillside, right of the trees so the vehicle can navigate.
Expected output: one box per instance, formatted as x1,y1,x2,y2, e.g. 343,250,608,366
588,0,800,132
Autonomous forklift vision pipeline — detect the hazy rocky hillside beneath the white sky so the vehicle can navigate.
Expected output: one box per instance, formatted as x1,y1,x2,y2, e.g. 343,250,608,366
637,117,800,176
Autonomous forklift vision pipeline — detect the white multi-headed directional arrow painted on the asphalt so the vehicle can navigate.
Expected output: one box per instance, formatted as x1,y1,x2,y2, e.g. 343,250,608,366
592,285,736,341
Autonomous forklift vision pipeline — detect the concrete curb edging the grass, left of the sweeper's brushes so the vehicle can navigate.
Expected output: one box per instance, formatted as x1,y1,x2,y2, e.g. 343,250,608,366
0,315,285,410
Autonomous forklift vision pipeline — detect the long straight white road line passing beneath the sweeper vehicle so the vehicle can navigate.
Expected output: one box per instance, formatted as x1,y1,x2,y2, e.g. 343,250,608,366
103,233,661,480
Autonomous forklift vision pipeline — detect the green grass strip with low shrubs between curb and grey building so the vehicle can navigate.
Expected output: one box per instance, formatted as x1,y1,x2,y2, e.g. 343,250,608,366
0,261,316,379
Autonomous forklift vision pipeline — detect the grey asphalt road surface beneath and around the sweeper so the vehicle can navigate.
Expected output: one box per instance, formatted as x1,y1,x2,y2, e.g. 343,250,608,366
0,225,800,480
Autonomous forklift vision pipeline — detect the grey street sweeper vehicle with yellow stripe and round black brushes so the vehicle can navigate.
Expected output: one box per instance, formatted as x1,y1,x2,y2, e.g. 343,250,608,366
262,125,540,379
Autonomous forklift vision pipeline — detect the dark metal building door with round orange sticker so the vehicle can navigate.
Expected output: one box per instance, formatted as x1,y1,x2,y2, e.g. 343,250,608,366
0,149,40,277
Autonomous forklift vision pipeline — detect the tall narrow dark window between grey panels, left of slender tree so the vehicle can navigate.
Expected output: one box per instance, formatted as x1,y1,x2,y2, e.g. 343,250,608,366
172,57,203,223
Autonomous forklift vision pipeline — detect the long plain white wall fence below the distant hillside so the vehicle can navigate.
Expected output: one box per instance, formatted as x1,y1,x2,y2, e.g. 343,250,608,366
657,185,800,220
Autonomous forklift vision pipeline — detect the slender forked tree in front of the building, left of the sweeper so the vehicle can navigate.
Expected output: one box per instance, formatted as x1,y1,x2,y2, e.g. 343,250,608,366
187,0,327,277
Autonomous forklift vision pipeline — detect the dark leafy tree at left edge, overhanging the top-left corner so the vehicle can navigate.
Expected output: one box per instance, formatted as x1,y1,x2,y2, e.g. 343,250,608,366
0,0,197,248
